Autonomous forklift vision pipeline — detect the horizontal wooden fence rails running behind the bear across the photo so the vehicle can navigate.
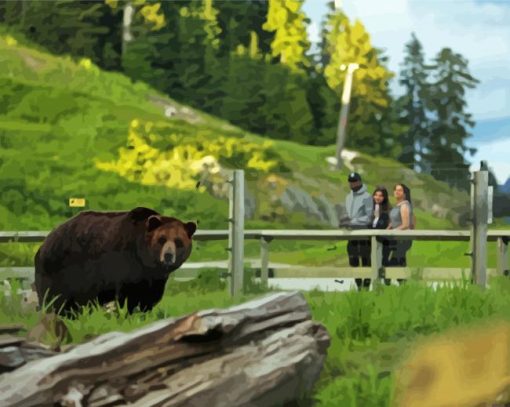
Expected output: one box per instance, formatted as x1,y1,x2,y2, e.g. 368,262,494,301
0,229,510,283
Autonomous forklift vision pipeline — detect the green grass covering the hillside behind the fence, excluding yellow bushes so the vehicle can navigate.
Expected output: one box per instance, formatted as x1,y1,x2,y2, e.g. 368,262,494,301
0,27,478,234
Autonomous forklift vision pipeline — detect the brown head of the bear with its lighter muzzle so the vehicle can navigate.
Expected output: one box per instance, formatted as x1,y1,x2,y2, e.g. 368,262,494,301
145,214,197,272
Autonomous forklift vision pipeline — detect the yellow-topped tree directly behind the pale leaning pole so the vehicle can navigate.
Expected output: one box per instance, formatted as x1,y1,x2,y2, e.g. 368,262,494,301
321,11,397,154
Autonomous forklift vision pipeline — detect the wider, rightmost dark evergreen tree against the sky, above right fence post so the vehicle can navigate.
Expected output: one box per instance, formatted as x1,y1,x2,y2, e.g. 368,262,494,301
423,48,479,189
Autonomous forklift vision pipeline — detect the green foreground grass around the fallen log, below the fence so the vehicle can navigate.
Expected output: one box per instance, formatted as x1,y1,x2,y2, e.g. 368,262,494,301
0,270,510,406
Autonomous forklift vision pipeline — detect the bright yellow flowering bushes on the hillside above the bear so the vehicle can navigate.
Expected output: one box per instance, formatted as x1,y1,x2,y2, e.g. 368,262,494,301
96,119,286,191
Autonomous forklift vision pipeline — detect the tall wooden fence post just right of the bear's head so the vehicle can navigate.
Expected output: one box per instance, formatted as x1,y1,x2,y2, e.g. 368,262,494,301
228,170,244,296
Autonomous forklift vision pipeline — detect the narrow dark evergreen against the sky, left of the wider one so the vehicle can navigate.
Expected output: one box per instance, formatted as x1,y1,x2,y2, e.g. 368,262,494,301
399,33,431,170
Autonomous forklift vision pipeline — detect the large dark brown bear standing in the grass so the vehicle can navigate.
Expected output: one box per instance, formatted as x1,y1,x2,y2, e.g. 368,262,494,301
35,207,197,314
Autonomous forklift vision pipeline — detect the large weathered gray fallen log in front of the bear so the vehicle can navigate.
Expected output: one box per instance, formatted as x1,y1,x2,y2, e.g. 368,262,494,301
0,293,329,407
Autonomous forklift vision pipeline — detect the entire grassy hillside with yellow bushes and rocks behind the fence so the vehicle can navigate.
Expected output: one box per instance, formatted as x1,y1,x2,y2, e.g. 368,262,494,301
0,31,468,236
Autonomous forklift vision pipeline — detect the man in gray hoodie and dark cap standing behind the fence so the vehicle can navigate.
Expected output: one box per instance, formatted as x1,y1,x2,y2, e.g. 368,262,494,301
340,172,374,289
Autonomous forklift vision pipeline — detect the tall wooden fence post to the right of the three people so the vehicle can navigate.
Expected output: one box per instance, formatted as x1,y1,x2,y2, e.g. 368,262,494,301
471,161,489,288
